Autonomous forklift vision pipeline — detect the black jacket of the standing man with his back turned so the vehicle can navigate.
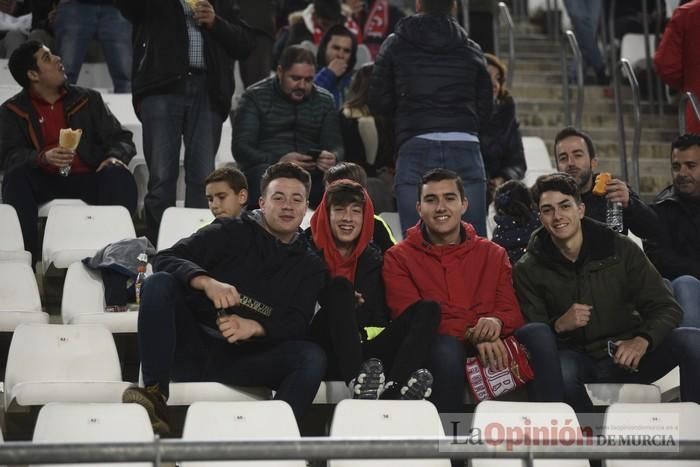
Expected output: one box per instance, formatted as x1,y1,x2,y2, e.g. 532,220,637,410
369,13,493,148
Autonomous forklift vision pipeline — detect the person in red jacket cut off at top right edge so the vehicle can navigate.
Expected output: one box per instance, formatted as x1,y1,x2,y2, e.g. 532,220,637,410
654,0,700,133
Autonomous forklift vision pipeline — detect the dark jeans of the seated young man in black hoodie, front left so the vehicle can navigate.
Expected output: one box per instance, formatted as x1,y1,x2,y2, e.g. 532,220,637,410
138,272,326,419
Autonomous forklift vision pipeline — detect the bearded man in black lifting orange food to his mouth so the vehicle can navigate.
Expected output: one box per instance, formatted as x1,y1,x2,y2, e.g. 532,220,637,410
554,127,658,239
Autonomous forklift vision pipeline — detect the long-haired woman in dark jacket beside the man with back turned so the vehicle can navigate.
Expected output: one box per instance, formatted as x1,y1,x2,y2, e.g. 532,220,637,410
479,54,527,203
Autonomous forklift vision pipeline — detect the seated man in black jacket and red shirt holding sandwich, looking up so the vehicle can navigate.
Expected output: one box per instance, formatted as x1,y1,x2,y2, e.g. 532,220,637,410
0,41,136,264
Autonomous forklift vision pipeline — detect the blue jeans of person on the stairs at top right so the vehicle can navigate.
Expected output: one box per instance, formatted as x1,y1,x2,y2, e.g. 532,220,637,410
564,0,605,74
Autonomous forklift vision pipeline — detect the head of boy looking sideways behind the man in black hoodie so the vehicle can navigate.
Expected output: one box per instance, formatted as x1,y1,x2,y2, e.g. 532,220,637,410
204,167,248,219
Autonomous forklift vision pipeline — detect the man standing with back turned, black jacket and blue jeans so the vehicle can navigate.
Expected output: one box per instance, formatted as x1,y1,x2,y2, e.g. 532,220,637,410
369,0,493,235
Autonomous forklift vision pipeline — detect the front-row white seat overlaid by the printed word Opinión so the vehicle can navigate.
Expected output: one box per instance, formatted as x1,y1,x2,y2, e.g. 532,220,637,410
471,401,590,467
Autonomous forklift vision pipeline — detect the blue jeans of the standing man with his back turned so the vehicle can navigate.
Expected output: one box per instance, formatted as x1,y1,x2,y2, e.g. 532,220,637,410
394,138,486,236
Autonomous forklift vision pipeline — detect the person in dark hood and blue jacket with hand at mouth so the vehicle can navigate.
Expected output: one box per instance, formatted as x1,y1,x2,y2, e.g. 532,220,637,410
314,24,357,107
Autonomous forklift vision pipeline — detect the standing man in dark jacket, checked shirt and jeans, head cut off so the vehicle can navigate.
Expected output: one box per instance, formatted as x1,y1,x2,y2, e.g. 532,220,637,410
117,0,255,245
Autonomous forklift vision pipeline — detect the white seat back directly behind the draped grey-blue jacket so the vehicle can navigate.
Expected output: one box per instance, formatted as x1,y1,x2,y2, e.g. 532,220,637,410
42,206,136,272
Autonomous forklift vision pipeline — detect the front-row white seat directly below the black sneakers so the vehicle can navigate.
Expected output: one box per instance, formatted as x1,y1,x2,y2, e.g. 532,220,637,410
328,399,450,467
